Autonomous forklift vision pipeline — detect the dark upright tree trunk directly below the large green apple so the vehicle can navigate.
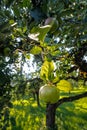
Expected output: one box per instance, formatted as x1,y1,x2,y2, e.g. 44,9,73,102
46,104,58,130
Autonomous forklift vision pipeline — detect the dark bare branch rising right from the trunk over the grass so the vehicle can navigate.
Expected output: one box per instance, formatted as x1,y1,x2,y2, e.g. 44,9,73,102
56,92,87,108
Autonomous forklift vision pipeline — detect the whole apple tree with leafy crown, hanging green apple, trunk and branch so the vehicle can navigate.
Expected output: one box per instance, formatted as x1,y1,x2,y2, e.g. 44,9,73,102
0,0,87,130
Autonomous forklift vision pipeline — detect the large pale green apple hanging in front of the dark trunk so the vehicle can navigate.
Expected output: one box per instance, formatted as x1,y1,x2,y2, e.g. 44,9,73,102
39,84,59,104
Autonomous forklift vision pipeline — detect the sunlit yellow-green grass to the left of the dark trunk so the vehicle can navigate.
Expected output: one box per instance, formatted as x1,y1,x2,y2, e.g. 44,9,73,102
9,100,45,130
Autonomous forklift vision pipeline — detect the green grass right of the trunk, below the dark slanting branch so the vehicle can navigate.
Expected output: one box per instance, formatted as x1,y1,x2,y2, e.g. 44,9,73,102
56,98,87,130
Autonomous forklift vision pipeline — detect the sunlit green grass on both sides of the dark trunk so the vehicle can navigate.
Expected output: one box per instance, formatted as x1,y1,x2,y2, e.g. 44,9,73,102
4,90,87,130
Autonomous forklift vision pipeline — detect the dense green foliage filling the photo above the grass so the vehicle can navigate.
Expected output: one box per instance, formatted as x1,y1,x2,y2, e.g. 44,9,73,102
0,0,87,130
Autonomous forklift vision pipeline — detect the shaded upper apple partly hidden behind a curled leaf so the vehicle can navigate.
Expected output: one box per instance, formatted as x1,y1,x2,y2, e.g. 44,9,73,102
44,17,59,33
